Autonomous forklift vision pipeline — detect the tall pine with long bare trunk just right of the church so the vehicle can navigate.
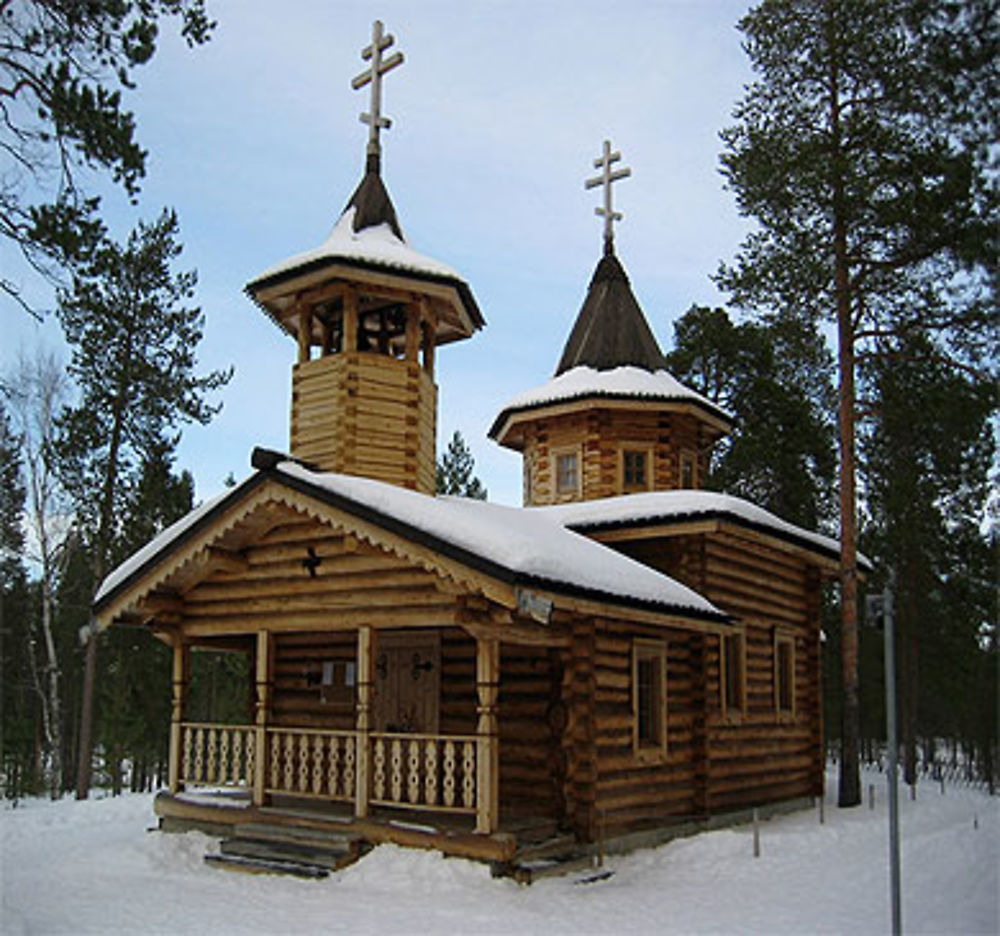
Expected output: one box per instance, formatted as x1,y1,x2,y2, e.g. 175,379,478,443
720,0,1000,806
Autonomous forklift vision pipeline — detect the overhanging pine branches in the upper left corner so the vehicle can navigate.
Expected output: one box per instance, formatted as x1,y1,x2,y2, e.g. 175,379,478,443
0,0,214,311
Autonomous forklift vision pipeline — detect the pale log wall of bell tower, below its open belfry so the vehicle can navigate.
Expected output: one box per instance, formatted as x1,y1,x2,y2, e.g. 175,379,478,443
290,351,437,493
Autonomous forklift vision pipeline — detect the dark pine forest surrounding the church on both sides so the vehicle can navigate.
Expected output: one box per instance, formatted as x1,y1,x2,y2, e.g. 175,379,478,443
0,0,1000,805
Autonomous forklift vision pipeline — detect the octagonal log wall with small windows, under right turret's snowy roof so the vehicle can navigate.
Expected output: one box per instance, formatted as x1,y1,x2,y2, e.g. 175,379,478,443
523,409,707,505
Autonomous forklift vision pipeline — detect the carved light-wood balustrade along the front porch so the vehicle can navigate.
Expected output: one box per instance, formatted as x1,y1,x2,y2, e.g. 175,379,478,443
180,722,479,813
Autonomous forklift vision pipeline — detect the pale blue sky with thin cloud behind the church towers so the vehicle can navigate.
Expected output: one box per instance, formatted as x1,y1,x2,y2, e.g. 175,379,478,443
0,0,750,504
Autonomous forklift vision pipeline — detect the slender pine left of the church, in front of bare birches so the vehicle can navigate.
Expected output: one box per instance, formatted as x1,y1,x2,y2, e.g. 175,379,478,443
58,211,232,797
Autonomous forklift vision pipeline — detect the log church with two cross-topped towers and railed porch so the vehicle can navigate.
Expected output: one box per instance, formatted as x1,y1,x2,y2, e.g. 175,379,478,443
94,23,838,867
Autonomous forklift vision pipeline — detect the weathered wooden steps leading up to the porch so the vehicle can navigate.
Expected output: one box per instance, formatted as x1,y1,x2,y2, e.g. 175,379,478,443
205,822,366,879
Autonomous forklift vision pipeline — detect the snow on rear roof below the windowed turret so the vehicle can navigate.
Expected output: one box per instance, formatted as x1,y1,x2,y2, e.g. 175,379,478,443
533,490,868,564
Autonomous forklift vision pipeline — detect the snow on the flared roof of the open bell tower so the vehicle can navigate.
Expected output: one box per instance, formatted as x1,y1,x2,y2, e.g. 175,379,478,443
251,205,464,283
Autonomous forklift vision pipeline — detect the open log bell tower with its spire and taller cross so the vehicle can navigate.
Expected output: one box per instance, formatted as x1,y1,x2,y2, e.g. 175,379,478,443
246,20,485,494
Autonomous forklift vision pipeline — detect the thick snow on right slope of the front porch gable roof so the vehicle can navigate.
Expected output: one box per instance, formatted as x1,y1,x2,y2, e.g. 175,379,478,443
277,462,721,616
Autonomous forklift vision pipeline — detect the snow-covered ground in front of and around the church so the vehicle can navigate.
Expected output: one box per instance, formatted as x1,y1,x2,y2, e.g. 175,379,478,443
0,774,1000,936
